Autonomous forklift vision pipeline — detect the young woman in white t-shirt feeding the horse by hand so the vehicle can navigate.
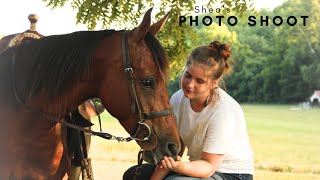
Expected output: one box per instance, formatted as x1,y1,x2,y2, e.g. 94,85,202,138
124,41,254,180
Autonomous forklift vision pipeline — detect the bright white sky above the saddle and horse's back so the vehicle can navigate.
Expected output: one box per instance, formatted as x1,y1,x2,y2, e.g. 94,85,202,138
0,0,283,36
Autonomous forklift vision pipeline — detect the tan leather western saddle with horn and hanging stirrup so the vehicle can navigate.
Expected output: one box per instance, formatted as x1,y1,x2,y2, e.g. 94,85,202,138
0,14,105,179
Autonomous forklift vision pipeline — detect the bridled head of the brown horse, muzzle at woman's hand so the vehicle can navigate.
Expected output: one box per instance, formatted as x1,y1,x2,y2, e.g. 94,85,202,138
93,9,180,163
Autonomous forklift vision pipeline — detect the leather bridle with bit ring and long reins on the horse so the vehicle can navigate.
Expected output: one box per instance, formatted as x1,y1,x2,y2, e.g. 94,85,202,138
11,31,172,145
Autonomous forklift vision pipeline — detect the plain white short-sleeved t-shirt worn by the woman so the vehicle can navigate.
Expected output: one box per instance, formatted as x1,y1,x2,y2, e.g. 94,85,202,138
170,88,254,174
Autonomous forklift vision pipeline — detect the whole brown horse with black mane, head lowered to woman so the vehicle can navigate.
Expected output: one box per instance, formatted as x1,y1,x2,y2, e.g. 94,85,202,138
0,9,180,179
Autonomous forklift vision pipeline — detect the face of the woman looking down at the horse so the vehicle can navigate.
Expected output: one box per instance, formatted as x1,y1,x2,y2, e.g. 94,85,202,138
181,63,216,101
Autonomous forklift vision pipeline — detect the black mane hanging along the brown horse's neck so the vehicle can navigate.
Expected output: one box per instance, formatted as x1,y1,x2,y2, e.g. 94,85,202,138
13,30,114,96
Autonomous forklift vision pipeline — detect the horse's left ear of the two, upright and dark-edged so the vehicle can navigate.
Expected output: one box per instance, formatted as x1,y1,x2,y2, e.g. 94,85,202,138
133,8,152,42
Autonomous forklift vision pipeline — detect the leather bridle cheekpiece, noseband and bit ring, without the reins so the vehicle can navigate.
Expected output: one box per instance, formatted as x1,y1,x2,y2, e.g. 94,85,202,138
121,31,172,141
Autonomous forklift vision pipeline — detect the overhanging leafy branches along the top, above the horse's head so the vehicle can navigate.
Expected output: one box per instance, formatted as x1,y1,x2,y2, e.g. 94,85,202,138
43,0,252,77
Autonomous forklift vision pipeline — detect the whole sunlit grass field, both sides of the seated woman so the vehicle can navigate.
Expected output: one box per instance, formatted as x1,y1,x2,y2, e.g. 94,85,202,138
86,105,320,180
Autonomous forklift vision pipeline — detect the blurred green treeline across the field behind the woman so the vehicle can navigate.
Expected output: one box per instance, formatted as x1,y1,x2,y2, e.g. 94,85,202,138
168,0,320,103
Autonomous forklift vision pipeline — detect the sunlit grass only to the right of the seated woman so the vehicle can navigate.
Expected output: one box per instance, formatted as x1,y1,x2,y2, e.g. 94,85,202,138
242,105,320,179
